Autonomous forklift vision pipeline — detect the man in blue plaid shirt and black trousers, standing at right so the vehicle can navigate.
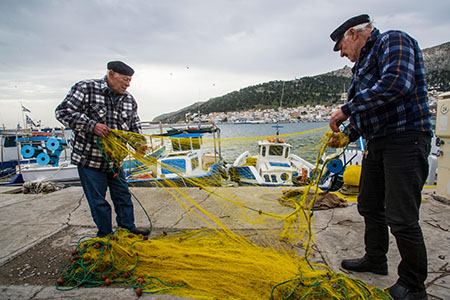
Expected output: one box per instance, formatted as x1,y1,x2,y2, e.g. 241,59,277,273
329,14,432,300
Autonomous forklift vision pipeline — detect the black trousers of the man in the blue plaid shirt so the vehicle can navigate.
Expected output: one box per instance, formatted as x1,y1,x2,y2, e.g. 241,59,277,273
358,131,431,290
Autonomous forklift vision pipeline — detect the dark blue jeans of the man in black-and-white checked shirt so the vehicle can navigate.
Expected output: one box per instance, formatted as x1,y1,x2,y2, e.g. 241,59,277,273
78,167,136,237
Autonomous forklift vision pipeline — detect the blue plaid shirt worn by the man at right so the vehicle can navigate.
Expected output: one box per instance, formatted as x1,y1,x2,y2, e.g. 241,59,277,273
341,28,431,141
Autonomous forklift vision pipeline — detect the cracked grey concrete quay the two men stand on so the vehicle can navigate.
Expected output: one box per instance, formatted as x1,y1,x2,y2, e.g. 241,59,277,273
0,187,450,300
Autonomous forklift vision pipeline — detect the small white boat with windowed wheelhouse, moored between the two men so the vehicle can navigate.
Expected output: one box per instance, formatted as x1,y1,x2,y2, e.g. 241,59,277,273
228,137,314,186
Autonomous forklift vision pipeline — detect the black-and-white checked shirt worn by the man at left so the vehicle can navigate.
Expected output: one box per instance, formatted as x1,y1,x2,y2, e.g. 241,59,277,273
55,76,141,172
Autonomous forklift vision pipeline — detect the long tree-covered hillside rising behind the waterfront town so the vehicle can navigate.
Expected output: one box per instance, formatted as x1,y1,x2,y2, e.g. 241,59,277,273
153,42,450,123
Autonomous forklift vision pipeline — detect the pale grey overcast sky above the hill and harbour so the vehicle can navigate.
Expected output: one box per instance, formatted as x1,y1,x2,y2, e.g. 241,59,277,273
0,0,450,127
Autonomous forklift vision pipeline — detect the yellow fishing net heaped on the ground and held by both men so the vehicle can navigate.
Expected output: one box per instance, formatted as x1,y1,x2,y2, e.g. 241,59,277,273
57,125,391,300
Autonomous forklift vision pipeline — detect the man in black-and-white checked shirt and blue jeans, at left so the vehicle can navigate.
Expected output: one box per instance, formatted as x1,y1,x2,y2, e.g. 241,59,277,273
55,61,150,237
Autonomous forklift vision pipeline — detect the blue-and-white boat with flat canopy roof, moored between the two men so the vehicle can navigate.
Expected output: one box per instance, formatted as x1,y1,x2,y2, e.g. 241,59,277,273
127,126,223,187
